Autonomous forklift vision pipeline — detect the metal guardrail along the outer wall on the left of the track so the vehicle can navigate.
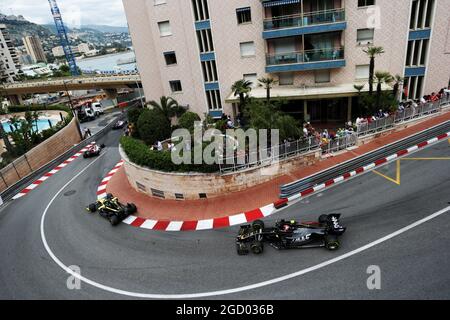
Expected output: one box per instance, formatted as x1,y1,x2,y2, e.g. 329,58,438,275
0,109,126,203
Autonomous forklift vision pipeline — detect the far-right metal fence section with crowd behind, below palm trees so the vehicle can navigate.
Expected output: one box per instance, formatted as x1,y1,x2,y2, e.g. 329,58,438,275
356,98,450,137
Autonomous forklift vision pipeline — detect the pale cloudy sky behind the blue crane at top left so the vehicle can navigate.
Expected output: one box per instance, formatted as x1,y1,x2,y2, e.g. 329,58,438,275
0,0,127,27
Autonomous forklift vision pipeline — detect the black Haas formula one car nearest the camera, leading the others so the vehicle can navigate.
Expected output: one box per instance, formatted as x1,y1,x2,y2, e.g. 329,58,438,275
236,214,346,255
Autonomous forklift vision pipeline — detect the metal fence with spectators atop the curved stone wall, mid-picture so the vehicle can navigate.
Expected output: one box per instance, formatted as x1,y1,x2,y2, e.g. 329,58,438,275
218,134,357,174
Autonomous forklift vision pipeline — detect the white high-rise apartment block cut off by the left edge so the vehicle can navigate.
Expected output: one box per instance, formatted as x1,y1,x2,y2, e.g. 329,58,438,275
0,24,20,83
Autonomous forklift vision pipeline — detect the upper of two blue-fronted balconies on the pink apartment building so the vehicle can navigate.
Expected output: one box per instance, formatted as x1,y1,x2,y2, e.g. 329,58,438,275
263,8,347,39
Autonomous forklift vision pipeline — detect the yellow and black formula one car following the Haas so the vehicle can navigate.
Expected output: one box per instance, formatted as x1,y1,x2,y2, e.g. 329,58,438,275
86,194,137,226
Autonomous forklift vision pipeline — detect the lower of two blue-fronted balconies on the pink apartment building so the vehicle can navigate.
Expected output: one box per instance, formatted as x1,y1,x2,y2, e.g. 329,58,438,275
266,48,345,73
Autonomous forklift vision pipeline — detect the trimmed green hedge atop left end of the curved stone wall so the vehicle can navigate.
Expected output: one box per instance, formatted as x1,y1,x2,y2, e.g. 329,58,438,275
120,136,219,173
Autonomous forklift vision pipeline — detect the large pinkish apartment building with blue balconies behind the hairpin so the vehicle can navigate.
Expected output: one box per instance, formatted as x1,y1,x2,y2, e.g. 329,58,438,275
123,0,450,122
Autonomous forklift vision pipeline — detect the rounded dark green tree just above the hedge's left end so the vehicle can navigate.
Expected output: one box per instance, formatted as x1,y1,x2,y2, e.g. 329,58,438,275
137,109,171,145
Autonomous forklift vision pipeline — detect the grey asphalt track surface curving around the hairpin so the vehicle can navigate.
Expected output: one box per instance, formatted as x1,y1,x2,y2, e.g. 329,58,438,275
0,128,450,300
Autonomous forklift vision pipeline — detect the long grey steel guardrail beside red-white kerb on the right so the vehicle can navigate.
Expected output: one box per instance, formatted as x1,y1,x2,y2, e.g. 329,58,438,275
280,121,450,199
